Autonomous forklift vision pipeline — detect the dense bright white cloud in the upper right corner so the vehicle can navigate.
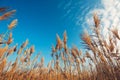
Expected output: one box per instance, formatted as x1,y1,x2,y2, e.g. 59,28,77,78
86,0,120,37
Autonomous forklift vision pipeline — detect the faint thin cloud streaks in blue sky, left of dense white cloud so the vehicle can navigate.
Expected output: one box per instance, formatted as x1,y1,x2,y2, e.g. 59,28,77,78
58,0,96,26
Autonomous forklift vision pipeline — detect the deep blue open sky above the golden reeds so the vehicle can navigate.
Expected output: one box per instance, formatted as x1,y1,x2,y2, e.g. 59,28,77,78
0,0,99,63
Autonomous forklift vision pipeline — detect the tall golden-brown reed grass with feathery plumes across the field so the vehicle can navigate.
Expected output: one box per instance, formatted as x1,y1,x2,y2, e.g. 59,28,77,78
0,8,120,80
